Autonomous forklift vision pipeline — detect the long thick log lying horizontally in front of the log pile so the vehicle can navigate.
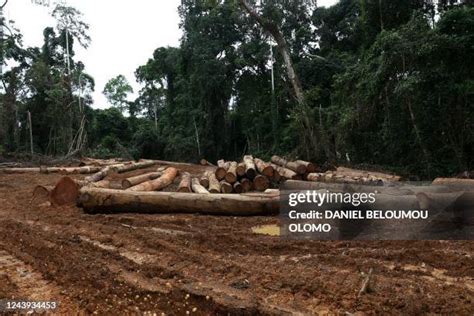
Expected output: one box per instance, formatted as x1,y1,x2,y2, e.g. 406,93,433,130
78,186,279,216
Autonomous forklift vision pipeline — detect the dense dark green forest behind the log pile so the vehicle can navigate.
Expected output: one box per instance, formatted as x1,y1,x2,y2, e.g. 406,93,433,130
0,0,474,178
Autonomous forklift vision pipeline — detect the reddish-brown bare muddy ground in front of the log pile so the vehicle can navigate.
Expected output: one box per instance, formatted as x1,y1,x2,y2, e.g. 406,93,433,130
0,167,474,315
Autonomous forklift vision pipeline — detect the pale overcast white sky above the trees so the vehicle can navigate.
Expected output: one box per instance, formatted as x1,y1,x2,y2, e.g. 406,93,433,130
5,0,337,108
